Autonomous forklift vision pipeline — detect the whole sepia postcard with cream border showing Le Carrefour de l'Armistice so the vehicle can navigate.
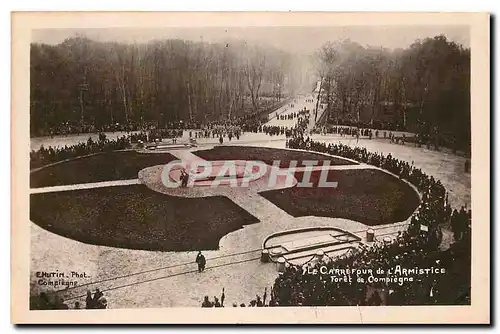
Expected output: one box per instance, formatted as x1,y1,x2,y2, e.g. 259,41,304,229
11,12,490,324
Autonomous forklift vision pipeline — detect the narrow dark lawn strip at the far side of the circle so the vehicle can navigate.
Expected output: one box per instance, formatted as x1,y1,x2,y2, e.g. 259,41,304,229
193,146,356,168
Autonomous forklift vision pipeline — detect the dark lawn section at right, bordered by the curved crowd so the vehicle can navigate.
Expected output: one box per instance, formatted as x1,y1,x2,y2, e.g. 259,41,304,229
260,169,420,226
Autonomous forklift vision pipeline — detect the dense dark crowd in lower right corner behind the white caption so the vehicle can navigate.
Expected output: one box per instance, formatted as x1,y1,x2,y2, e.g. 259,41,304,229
273,227,470,306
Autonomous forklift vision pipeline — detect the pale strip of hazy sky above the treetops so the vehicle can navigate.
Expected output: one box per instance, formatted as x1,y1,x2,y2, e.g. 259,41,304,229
32,25,470,54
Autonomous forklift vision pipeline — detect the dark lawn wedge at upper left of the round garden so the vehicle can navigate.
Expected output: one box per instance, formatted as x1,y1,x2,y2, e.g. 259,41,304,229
30,151,176,188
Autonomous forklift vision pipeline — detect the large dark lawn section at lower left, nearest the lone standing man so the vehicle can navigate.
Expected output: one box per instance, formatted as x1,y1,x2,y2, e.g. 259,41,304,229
30,185,258,251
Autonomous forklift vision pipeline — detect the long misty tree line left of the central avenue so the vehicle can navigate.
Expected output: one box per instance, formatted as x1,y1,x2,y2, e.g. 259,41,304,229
30,36,304,135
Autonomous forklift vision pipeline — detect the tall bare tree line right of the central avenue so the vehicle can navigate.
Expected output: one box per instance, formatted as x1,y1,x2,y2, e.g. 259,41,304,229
316,36,470,147
